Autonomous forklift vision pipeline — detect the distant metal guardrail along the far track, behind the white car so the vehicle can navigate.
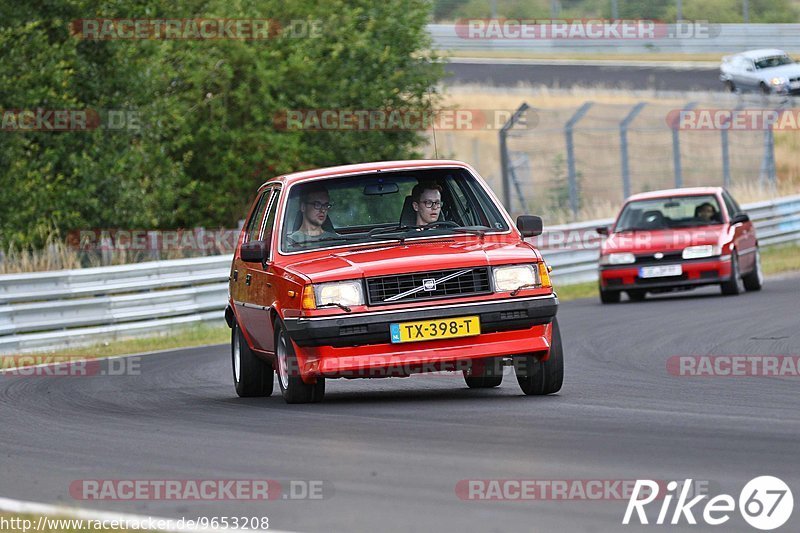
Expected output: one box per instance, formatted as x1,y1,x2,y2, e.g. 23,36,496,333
428,24,800,56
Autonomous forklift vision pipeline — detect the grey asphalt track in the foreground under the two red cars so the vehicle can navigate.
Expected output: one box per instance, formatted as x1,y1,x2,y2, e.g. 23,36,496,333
0,276,800,532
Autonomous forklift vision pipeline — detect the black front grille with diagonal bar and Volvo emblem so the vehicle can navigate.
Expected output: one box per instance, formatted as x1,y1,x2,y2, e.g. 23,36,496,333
367,267,491,305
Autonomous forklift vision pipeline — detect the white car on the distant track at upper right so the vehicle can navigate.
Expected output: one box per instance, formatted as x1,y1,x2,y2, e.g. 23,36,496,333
719,49,800,95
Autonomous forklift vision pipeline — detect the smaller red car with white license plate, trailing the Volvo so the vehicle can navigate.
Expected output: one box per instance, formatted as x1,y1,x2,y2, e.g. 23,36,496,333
597,187,763,303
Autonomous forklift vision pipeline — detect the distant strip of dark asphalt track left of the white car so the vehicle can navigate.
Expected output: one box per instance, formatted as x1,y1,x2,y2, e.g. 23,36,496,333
446,59,723,91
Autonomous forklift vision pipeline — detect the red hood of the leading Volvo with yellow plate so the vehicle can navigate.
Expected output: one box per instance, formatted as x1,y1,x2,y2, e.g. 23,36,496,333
286,237,539,283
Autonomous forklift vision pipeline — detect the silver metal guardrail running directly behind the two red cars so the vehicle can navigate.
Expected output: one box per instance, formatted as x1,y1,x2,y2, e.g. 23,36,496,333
0,195,800,353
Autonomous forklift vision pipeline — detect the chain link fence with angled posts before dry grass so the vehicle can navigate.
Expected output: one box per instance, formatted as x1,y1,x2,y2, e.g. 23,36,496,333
500,97,780,221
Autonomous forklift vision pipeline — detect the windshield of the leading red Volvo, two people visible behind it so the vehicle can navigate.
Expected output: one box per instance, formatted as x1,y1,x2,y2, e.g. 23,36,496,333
281,168,508,253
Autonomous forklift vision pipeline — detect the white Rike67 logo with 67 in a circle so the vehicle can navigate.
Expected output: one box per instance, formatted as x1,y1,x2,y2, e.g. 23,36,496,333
622,476,794,531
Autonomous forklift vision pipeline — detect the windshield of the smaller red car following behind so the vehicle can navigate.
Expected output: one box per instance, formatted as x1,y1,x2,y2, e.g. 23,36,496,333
614,195,722,233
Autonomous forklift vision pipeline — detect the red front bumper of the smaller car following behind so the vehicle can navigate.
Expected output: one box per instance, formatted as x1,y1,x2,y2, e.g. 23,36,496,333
600,255,731,290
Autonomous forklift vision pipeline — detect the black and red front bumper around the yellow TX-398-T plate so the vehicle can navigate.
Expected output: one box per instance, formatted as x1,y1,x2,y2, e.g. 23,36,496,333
284,295,558,378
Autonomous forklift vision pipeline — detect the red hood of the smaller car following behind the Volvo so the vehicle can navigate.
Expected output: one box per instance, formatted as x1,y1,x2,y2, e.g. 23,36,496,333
601,225,726,254
